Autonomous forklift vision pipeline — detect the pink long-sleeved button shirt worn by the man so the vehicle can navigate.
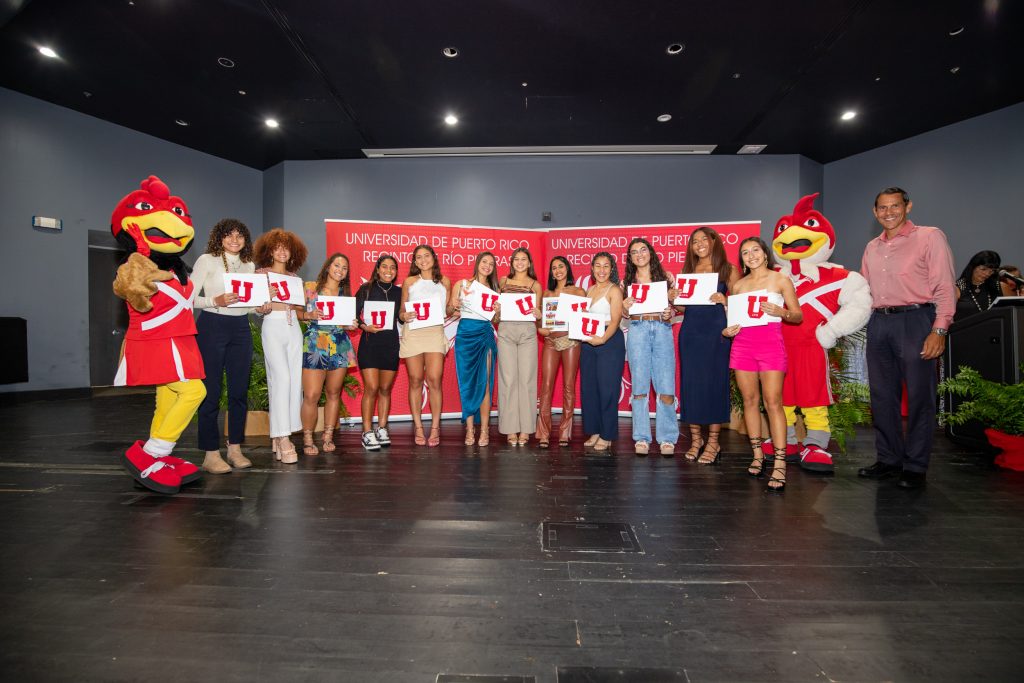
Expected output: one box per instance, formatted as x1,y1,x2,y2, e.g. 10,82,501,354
860,220,956,330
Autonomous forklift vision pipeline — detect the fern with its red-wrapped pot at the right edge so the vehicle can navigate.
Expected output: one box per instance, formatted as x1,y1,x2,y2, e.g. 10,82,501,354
939,366,1024,472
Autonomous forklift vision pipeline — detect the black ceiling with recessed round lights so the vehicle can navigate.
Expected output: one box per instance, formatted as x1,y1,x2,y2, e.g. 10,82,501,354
0,0,1024,169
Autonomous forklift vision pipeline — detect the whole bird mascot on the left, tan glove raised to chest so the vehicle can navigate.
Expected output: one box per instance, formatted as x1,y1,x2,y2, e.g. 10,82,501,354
111,175,206,494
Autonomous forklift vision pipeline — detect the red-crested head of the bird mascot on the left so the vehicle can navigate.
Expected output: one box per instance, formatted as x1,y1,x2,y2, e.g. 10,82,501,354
111,175,196,284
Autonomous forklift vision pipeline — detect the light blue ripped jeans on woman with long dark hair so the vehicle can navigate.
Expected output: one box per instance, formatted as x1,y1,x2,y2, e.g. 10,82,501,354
626,321,679,443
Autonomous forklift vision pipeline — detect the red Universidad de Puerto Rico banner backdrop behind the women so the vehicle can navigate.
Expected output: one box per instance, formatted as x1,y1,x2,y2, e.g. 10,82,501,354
325,220,761,419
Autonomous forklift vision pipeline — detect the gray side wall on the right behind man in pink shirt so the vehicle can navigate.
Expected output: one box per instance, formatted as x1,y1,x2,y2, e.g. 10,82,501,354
823,104,1024,273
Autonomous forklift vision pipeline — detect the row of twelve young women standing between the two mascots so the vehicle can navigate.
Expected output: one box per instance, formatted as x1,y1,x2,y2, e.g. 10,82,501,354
194,219,802,490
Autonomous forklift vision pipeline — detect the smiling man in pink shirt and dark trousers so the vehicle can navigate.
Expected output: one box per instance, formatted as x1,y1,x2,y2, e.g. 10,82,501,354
858,187,956,488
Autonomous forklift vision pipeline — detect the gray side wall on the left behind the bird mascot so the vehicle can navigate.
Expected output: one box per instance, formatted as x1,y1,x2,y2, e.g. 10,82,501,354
0,88,263,392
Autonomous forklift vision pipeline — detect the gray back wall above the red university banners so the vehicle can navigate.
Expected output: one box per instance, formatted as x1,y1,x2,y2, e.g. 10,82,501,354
264,156,821,276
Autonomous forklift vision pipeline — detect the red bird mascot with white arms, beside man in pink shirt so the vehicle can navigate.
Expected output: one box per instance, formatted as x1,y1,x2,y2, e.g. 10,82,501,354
772,193,871,474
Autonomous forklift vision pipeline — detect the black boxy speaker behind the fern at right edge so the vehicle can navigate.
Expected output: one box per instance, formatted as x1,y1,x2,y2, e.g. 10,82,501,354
945,305,1024,450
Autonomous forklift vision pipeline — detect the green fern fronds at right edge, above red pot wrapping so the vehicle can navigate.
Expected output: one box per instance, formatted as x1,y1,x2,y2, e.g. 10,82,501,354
939,366,1024,435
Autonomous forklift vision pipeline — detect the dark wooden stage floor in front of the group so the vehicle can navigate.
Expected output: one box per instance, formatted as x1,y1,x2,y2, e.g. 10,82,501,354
0,395,1024,683
